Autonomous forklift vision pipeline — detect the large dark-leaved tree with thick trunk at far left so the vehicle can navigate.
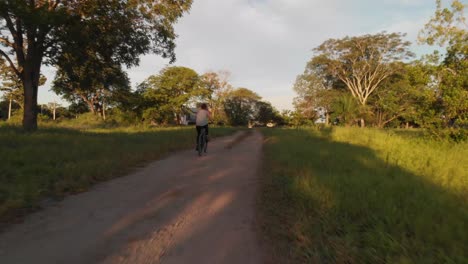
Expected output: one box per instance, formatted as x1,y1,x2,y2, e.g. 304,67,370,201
0,0,192,130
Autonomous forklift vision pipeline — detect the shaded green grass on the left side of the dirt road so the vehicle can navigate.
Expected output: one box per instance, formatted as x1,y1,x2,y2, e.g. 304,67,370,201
0,125,235,222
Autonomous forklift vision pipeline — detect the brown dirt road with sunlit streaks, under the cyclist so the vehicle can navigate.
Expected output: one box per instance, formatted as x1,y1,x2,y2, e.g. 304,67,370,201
0,132,262,264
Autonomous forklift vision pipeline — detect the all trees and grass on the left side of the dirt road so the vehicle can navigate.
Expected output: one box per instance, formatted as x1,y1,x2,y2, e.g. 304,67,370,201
0,0,279,227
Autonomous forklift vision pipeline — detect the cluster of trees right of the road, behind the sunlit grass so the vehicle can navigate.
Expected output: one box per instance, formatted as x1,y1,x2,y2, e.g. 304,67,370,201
294,0,468,128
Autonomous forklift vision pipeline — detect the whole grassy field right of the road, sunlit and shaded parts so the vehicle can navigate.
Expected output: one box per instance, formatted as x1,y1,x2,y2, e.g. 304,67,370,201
260,128,468,263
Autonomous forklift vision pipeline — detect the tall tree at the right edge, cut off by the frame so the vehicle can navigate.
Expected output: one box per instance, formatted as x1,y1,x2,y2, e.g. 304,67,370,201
419,0,468,126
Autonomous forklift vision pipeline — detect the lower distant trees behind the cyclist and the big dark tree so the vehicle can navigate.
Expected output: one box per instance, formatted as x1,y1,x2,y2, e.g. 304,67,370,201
0,66,284,126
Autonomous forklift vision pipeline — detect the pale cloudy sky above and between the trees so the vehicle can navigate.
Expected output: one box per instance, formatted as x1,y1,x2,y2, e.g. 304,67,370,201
35,0,446,110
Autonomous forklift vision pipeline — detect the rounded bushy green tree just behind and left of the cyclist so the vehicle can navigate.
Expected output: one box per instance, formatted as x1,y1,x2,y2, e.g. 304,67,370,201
139,66,205,124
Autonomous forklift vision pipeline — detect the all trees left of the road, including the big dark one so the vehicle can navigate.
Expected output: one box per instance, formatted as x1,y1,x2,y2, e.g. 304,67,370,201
0,0,279,130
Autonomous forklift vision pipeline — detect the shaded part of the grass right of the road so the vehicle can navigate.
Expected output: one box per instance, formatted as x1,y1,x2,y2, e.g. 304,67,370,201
263,130,468,263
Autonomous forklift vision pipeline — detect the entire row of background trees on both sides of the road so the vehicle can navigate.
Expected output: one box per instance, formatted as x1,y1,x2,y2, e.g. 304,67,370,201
0,0,468,130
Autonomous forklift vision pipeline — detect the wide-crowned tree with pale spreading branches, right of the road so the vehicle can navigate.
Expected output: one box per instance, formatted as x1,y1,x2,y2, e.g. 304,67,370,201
311,32,413,127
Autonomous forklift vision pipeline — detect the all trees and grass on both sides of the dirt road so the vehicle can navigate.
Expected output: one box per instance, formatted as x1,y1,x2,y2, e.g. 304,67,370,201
0,0,468,263
